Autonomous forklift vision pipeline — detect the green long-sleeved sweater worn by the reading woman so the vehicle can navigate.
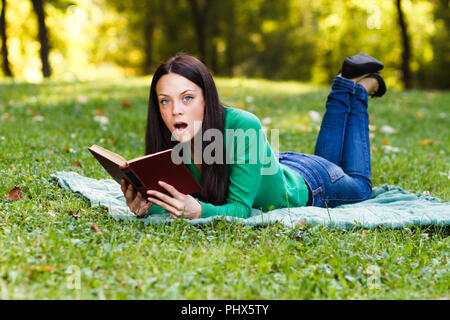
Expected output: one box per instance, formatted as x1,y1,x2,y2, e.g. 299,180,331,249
149,106,308,218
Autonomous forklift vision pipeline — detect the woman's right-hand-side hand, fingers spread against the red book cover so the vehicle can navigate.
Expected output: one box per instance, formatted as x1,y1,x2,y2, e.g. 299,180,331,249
147,181,203,219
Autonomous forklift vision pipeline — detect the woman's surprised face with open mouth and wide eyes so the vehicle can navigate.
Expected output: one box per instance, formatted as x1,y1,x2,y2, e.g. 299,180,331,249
156,73,205,142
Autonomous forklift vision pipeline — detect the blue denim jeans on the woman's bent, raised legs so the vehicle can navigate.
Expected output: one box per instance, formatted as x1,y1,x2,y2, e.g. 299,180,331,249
277,77,372,208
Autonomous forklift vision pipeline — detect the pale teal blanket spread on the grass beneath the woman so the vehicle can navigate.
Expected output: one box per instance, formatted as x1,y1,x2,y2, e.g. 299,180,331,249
51,171,450,229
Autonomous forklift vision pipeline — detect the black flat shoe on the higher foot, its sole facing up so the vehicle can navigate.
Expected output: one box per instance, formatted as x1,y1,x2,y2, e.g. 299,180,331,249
339,52,384,79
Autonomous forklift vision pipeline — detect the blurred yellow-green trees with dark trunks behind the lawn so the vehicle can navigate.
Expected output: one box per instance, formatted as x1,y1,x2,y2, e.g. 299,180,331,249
0,0,450,88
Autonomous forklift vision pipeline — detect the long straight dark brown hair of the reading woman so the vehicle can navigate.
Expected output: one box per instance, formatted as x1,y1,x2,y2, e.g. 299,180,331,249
145,54,228,205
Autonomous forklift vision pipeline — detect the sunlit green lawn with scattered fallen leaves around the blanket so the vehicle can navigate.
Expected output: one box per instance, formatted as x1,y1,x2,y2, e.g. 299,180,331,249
0,78,450,299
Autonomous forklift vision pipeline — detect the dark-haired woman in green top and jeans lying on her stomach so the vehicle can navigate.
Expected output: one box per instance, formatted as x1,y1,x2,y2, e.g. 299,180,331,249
121,53,386,219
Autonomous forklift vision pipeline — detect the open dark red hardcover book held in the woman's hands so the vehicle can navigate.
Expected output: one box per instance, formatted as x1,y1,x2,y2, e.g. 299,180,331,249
88,144,201,198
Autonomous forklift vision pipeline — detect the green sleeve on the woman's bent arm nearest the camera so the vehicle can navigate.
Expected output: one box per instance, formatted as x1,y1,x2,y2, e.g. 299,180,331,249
199,111,265,218
